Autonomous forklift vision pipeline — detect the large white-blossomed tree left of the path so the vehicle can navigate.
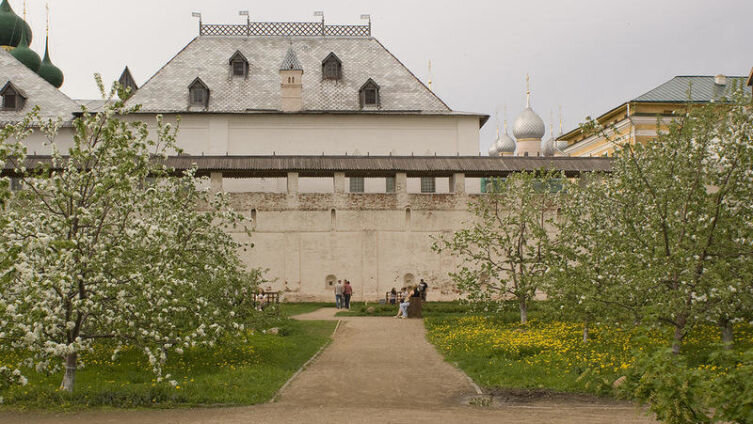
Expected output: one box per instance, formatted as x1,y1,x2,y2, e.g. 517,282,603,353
0,78,261,391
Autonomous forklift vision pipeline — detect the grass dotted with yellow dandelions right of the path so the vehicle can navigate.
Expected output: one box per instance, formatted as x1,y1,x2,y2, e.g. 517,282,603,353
425,315,753,394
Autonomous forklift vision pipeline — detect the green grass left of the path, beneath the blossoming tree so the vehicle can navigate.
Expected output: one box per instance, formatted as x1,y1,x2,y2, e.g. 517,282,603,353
2,320,336,409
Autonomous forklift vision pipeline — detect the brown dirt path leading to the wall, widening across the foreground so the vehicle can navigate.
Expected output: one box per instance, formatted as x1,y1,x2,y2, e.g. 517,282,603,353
0,309,654,424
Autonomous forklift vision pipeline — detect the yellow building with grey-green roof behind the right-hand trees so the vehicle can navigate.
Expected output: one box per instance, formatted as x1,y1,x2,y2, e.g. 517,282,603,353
558,75,749,157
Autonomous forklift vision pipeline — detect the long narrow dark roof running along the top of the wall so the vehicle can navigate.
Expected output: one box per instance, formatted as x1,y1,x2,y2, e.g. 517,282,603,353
4,156,611,177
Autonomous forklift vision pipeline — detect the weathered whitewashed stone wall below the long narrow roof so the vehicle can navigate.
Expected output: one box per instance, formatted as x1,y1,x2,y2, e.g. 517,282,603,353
229,190,473,302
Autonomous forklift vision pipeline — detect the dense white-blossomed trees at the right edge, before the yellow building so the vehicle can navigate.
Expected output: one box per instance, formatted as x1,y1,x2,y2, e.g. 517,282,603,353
551,91,753,352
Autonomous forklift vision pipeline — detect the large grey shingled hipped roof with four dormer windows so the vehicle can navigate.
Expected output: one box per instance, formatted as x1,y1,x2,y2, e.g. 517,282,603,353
128,36,450,113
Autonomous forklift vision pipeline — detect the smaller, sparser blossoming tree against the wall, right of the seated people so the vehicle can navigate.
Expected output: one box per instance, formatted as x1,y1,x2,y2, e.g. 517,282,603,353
432,172,562,322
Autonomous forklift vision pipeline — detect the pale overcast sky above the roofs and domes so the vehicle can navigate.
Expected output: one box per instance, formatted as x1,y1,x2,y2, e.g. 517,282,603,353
11,0,753,153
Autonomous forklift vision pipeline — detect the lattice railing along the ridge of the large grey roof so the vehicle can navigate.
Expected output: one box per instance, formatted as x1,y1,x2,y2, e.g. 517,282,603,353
199,19,371,37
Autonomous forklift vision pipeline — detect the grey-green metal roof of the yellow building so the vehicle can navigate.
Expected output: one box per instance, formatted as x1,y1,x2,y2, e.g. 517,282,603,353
631,76,745,103
